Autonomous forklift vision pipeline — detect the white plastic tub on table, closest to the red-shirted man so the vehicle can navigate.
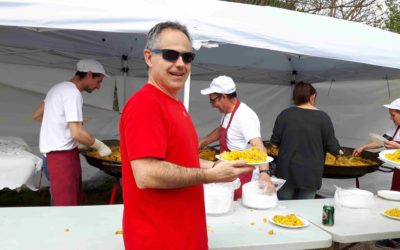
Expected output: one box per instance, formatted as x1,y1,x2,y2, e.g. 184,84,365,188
204,179,240,215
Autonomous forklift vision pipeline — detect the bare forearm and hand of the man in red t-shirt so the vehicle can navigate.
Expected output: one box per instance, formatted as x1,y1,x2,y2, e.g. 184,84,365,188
131,158,254,189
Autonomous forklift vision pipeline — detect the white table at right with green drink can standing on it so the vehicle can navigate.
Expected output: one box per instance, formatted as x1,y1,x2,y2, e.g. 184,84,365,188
280,197,400,247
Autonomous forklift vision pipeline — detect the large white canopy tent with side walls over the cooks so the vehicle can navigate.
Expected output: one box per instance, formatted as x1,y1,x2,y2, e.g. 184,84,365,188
0,0,400,192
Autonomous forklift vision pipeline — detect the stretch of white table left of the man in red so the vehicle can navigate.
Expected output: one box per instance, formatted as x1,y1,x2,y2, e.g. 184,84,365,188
0,205,124,250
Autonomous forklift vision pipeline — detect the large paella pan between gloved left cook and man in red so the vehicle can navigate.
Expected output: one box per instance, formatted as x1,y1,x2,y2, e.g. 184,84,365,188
80,140,121,177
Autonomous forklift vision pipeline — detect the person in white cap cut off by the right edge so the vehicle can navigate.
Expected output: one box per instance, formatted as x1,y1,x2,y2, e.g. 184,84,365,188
353,98,400,249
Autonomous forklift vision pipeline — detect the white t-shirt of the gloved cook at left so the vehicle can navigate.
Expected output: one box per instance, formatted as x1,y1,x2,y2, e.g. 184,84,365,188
39,82,83,153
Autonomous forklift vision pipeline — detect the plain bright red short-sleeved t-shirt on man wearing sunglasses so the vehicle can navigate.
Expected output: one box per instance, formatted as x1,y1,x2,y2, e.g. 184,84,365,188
120,84,208,249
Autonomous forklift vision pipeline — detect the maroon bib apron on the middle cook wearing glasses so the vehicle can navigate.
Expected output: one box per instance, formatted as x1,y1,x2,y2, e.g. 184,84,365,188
219,100,253,201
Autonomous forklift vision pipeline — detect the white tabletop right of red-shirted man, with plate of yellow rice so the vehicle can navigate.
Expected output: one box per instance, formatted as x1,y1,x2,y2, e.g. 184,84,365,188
207,202,332,249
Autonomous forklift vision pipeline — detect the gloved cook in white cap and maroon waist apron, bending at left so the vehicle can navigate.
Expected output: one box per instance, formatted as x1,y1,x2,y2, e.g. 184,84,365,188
33,59,111,206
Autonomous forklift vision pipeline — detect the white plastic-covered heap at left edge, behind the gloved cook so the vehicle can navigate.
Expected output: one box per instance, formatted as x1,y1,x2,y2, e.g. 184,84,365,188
0,136,43,190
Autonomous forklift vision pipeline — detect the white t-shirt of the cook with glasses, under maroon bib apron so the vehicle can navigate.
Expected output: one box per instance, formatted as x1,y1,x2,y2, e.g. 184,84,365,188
221,102,261,150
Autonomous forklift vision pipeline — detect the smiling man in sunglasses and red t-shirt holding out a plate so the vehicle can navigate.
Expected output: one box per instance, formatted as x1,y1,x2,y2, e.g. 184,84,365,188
120,22,253,249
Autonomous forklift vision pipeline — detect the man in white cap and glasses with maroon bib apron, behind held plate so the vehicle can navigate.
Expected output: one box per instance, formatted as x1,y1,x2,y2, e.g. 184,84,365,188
199,75,275,200
